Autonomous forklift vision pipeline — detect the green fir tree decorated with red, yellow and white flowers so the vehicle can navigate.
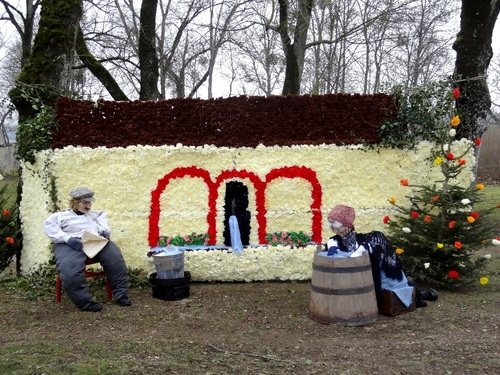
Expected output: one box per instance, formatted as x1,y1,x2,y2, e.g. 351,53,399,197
383,89,500,289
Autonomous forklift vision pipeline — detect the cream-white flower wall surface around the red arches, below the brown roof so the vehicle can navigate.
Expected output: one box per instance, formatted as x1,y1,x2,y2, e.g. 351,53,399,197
21,140,475,281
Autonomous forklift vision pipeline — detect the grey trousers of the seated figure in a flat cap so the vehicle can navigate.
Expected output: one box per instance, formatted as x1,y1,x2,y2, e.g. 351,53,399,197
54,241,128,309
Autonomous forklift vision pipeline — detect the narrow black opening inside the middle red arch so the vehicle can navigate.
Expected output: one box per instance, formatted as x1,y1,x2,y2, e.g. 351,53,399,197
223,181,251,246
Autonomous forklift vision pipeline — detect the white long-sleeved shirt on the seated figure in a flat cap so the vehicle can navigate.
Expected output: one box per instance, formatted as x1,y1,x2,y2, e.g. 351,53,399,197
43,209,111,243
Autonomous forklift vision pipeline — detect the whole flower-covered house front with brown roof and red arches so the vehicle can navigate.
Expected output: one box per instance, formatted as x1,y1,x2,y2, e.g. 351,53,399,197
17,95,474,281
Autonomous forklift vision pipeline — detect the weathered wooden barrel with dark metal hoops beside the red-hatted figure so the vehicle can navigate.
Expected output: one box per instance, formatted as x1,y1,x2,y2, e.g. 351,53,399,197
309,253,378,326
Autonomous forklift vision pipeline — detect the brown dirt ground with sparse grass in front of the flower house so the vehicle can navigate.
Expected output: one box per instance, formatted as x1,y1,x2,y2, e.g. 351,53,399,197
0,262,500,375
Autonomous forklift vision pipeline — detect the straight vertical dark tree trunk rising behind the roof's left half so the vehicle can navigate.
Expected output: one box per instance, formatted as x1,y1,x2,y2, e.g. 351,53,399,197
139,0,159,100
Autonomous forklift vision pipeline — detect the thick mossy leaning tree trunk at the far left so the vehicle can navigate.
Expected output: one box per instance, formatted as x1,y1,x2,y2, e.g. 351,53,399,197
9,0,83,121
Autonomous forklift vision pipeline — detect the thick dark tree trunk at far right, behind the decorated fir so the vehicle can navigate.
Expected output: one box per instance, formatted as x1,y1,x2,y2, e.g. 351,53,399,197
453,0,500,139
